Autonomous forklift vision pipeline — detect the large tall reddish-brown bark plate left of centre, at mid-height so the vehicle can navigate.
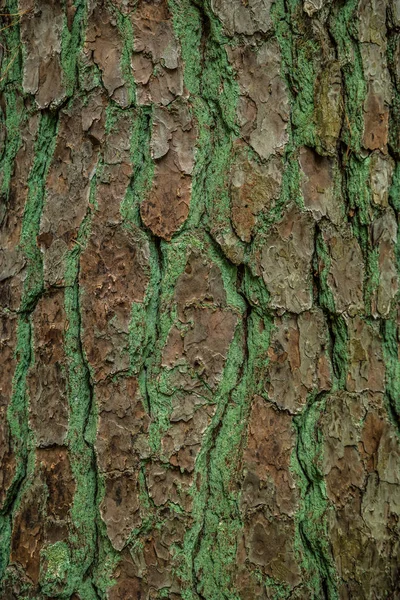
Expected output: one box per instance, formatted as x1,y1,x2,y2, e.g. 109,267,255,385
80,225,149,381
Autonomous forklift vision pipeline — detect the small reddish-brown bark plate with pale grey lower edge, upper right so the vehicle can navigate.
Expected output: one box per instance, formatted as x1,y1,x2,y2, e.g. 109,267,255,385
300,147,344,224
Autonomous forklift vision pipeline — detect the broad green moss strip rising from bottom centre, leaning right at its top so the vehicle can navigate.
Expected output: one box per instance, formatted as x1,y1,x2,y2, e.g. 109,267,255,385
180,307,271,600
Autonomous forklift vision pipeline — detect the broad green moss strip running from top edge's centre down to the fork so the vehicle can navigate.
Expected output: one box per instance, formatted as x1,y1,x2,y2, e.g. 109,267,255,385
170,0,240,243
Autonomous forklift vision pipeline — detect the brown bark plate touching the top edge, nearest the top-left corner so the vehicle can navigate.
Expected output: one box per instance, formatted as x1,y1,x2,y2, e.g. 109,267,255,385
19,0,66,109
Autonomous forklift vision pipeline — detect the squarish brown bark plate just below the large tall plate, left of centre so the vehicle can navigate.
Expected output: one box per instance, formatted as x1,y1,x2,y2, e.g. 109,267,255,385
95,377,149,472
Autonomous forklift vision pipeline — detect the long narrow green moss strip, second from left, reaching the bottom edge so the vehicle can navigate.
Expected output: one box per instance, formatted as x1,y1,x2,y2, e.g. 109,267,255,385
64,169,100,600
